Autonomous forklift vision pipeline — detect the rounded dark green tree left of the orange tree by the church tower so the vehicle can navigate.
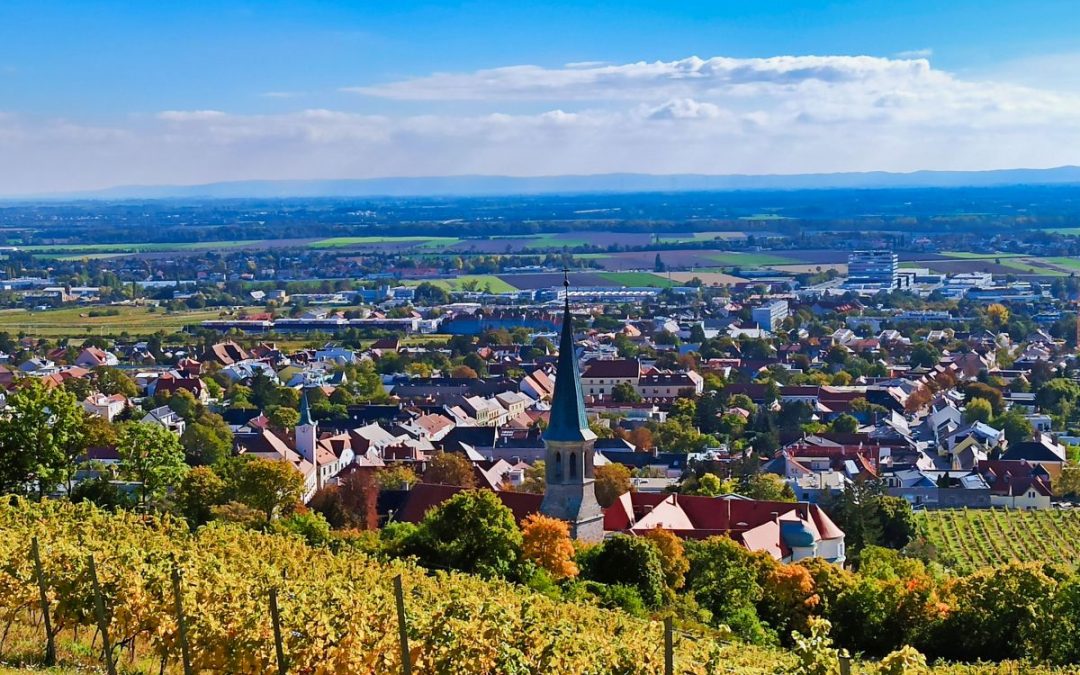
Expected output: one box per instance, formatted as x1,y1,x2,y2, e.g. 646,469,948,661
405,490,522,578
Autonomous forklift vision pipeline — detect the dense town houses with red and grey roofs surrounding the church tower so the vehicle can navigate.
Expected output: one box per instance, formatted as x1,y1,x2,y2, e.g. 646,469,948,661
10,252,1075,563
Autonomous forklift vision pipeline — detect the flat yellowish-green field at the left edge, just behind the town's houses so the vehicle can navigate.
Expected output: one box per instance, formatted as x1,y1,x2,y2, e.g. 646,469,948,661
0,306,221,338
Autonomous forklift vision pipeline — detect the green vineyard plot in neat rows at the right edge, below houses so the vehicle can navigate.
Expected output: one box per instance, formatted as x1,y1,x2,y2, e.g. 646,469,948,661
920,509,1080,571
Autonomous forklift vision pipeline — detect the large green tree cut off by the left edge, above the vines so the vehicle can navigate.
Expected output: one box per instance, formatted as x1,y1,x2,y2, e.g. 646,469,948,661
0,378,86,497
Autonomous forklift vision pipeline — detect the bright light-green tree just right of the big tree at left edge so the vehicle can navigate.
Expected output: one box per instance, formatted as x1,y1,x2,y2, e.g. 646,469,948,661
117,422,188,509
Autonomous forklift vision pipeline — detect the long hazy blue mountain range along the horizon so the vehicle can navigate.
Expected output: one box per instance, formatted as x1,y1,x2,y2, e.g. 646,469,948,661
23,166,1080,200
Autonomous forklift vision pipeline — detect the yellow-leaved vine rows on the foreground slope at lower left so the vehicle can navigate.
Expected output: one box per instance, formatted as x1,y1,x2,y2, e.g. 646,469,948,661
0,499,734,675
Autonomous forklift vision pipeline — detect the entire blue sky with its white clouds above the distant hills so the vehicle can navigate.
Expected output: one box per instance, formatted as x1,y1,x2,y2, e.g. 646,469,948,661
0,0,1080,193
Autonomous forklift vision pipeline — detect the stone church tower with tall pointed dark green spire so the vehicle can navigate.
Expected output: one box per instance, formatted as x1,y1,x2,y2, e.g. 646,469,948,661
540,271,604,541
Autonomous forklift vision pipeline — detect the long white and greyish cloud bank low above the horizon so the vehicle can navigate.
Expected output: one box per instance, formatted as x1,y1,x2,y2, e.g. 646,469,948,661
0,52,1080,194
